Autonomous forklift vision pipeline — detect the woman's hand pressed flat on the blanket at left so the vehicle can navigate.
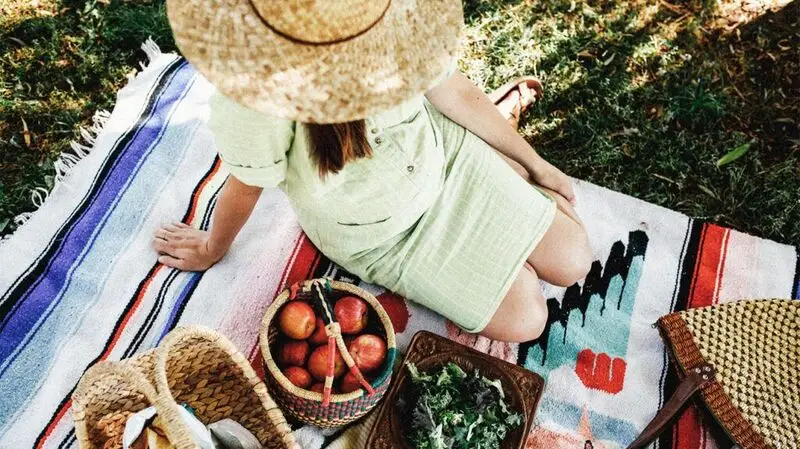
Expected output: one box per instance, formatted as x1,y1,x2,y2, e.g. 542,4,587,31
153,223,228,271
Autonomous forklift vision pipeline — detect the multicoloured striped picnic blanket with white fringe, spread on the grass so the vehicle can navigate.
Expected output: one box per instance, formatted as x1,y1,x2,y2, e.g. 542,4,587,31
0,43,800,449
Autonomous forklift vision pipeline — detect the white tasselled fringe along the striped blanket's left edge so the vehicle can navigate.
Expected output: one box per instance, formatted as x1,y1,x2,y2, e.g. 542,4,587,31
0,37,166,245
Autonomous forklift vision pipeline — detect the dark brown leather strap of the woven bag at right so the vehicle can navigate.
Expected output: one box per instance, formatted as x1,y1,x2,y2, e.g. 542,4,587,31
627,364,716,449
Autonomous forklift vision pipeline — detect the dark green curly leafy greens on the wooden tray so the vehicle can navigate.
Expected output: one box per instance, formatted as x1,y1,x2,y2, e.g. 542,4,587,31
406,363,523,449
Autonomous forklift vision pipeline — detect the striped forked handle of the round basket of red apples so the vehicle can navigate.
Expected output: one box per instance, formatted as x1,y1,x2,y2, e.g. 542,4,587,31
302,279,375,407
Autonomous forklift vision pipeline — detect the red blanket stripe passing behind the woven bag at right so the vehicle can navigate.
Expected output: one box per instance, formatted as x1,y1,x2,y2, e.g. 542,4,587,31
672,224,730,449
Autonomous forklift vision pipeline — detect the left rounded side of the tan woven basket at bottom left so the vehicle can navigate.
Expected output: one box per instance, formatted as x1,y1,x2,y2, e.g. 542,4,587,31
72,351,158,449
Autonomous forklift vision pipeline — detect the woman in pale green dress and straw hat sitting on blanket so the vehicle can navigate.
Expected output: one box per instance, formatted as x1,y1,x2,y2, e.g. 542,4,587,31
154,0,591,341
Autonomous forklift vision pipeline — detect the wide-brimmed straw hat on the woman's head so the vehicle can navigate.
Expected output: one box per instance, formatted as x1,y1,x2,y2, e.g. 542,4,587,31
167,0,463,123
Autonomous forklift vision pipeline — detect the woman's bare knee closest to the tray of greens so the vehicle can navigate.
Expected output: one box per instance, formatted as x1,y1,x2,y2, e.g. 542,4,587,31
481,264,547,342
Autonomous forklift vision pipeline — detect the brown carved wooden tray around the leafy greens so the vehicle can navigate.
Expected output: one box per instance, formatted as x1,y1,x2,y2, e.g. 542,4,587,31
366,331,544,449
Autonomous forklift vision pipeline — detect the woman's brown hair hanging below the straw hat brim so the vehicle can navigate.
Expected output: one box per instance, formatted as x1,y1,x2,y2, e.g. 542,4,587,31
305,120,372,178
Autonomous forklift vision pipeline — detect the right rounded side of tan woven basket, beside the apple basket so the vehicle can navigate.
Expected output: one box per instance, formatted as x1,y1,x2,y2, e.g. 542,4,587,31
156,326,300,449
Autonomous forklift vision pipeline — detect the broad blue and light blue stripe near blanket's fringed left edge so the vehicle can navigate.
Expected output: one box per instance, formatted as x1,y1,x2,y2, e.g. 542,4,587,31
0,61,199,432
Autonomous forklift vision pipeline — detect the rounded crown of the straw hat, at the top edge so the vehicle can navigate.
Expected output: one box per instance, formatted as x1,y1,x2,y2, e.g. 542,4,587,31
248,0,391,45
